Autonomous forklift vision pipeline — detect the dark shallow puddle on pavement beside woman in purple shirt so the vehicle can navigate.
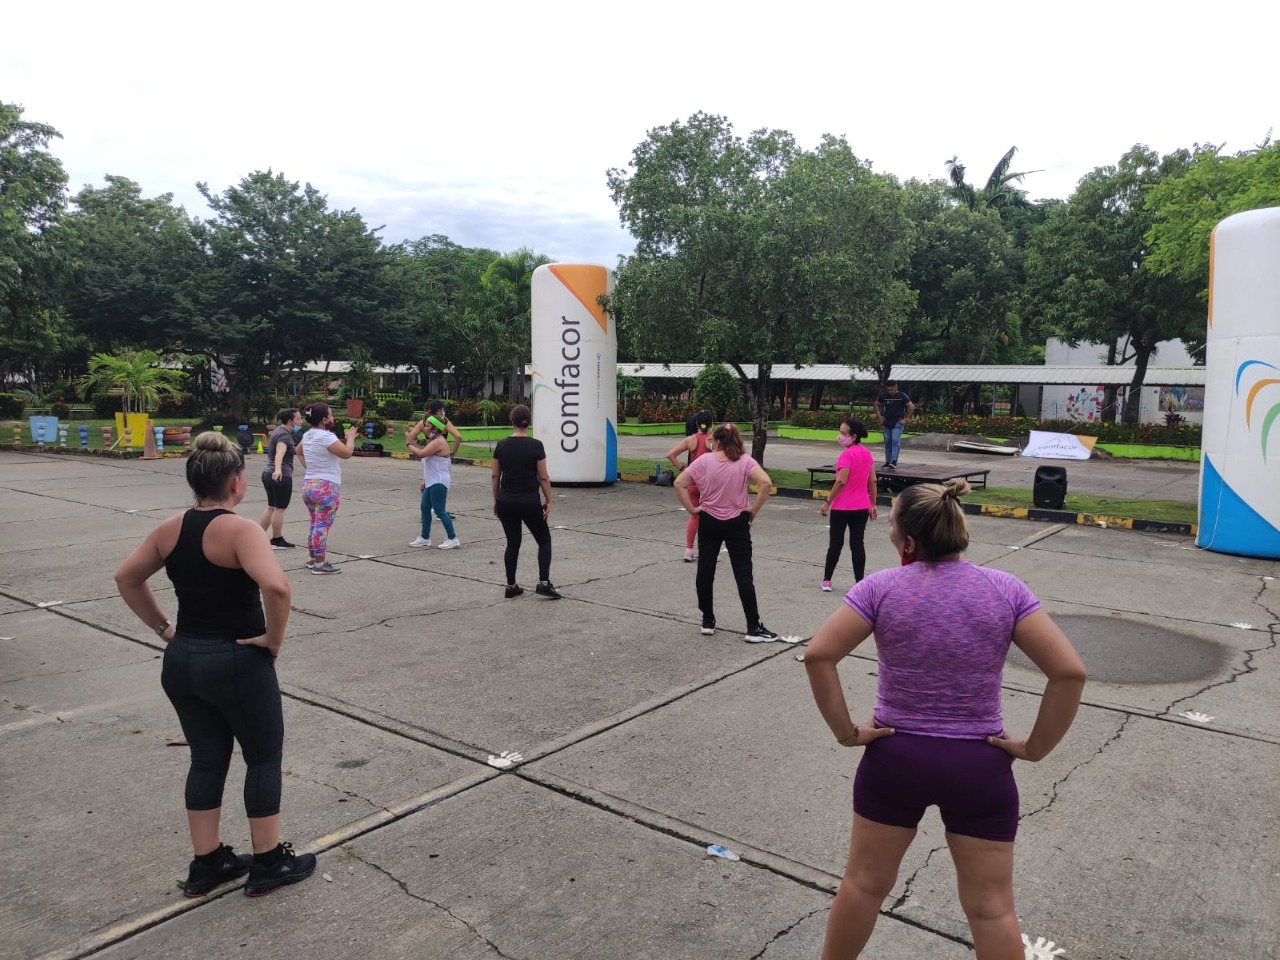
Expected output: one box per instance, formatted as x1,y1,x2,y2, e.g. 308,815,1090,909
1009,614,1228,684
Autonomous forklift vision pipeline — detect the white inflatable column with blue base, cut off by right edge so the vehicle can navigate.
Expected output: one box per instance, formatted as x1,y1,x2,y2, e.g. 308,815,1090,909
1196,207,1280,557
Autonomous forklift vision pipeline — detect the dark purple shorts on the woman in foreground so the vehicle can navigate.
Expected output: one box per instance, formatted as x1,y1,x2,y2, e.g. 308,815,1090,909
854,733,1018,844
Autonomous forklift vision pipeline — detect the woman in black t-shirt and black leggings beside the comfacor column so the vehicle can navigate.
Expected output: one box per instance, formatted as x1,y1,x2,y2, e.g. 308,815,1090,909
490,403,559,600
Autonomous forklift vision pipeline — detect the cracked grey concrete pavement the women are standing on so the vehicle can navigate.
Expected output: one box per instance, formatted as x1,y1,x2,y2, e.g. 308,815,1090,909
0,450,1280,960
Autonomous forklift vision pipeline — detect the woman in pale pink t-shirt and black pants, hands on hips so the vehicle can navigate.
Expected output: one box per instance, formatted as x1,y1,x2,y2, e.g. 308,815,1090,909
676,424,778,644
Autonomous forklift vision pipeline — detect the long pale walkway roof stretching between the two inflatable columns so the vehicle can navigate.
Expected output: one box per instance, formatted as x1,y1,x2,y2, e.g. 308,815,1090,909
618,362,1204,387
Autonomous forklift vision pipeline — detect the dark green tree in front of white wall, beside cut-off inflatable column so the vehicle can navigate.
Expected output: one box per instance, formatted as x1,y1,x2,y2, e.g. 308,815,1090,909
1027,145,1204,422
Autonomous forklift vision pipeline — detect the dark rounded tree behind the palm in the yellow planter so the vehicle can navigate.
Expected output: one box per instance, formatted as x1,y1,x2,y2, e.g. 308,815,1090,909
61,175,204,351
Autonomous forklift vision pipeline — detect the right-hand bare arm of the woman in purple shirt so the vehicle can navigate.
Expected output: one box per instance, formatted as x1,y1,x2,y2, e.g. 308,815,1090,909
987,609,1085,760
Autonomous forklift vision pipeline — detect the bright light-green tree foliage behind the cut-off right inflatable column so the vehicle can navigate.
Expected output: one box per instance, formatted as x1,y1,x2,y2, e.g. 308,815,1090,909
1146,137,1280,302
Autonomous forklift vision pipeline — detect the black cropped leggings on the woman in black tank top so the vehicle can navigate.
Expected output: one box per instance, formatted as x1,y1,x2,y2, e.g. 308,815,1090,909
160,636,284,818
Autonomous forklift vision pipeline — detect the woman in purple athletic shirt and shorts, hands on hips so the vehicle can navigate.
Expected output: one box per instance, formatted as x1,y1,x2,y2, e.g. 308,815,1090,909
805,480,1084,960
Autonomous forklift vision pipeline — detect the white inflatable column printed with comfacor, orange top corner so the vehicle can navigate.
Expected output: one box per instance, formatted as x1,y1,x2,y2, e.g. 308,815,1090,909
530,264,618,484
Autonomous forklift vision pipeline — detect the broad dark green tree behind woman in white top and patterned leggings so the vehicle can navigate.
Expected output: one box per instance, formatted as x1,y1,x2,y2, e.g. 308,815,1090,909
186,170,403,416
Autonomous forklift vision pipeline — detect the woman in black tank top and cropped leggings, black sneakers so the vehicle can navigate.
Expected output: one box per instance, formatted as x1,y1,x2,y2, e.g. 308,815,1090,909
115,431,316,897
